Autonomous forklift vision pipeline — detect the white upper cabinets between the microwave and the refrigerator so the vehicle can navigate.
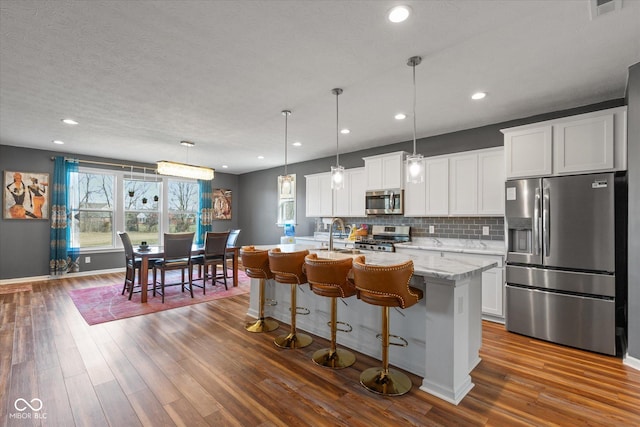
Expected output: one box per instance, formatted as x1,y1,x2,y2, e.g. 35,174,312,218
404,147,505,216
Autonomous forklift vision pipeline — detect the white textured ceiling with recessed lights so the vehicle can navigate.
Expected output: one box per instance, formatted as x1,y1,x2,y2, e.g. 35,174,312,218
0,0,640,173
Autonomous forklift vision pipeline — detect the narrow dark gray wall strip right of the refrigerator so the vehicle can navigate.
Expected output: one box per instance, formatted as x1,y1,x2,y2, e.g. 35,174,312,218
627,62,640,360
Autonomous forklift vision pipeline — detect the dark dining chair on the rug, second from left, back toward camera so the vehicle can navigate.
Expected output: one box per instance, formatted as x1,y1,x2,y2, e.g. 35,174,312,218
153,233,195,303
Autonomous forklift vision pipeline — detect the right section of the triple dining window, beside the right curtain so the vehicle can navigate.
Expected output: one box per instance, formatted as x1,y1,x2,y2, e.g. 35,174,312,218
168,180,198,233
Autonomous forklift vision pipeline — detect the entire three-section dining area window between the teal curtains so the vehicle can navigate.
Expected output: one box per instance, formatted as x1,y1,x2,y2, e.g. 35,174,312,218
70,167,199,250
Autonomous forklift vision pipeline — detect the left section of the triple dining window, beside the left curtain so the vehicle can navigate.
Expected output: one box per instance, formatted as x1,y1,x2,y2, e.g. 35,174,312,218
70,172,116,248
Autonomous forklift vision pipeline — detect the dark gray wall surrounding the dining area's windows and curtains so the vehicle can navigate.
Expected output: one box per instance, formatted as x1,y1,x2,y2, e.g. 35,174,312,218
0,145,240,280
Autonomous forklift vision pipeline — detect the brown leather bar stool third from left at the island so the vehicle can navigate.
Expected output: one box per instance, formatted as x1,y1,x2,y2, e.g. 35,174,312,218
304,254,356,369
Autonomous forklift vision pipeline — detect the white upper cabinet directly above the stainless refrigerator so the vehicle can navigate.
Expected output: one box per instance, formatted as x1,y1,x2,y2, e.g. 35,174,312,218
502,107,627,178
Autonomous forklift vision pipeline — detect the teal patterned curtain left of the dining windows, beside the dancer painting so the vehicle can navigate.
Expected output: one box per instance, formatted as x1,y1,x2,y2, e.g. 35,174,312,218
49,156,80,276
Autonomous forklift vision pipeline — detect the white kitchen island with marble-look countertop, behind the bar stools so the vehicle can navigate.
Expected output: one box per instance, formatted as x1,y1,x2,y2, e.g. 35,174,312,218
248,245,496,404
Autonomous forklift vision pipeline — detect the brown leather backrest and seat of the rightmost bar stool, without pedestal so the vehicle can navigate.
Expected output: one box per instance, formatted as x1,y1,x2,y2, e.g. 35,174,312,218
353,255,421,308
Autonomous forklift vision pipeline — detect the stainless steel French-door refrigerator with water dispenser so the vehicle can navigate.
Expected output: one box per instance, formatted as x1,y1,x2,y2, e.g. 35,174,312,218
505,173,626,355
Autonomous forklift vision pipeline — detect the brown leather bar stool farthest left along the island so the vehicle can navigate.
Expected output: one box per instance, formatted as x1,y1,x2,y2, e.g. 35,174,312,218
240,246,280,332
